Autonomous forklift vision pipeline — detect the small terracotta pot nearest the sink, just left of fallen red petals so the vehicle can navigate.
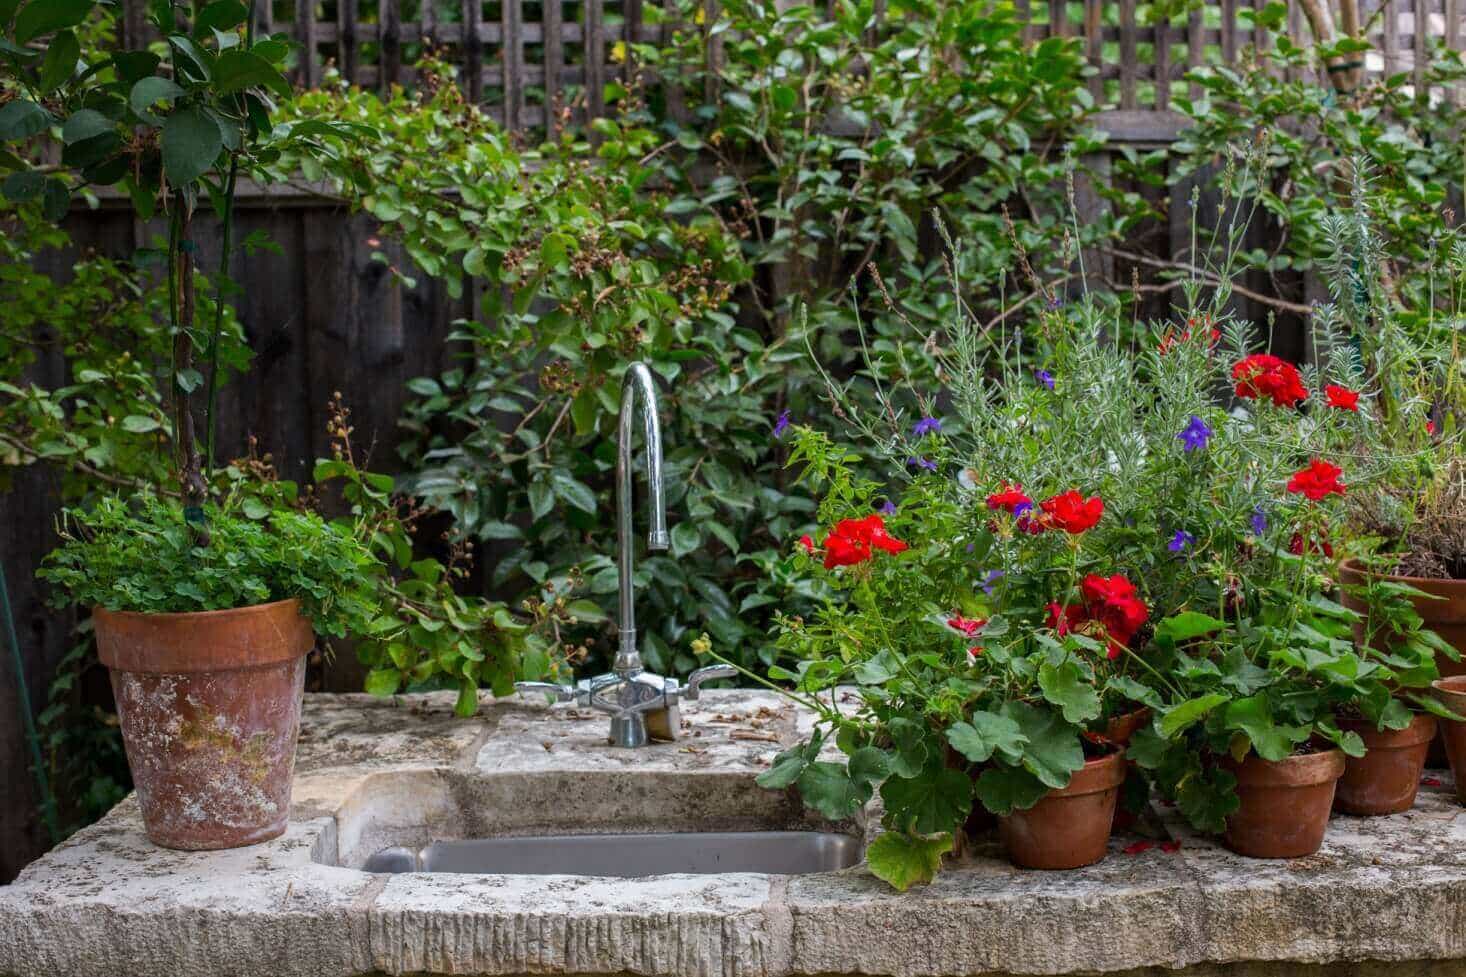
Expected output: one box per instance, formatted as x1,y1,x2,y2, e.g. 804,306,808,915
998,750,1124,868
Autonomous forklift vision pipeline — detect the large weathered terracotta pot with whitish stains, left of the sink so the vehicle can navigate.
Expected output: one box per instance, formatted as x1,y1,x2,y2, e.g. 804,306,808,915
92,600,315,851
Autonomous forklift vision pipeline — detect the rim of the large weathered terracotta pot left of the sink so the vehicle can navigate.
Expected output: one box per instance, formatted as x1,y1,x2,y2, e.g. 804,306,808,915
92,597,315,675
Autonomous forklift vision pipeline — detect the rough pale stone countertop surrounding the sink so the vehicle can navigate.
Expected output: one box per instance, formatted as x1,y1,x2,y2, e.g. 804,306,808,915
0,691,1466,977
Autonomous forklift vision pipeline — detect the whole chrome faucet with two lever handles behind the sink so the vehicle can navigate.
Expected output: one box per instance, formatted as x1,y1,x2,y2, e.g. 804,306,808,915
515,362,737,747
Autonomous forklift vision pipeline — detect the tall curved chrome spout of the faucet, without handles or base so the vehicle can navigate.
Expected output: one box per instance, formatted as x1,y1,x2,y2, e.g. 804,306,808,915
611,362,668,678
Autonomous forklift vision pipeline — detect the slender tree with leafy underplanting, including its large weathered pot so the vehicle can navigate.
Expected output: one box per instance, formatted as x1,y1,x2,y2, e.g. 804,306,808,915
10,0,567,849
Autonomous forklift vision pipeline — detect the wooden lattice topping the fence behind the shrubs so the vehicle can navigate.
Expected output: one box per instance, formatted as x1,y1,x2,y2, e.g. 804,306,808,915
123,0,1463,141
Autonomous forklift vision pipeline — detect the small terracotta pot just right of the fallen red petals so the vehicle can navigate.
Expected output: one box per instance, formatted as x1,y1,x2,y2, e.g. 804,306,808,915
1223,750,1344,858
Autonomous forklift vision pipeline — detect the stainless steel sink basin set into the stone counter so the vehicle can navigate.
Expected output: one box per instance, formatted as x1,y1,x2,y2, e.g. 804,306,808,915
362,832,861,879
